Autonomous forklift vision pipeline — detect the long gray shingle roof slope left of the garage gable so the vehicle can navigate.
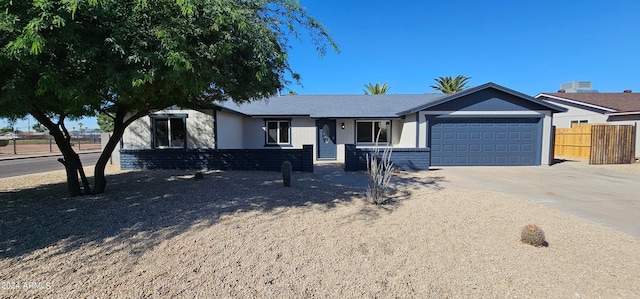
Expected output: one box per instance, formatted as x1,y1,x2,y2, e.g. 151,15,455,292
218,93,447,118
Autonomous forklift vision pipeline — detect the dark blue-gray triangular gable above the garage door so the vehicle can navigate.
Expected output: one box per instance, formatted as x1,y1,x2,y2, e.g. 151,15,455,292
401,82,567,114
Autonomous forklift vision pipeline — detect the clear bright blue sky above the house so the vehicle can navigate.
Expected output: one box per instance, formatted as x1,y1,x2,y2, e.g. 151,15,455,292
0,0,640,130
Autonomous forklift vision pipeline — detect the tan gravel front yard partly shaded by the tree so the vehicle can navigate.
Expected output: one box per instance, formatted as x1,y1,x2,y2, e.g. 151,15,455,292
0,168,640,298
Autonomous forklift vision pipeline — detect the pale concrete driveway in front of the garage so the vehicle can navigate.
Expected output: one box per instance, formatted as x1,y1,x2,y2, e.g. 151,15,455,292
436,161,640,238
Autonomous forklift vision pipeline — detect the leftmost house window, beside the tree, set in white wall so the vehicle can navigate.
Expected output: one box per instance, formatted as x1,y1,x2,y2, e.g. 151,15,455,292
151,116,187,148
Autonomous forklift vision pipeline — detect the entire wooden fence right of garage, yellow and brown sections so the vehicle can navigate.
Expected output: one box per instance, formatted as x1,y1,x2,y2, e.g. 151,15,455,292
554,124,636,164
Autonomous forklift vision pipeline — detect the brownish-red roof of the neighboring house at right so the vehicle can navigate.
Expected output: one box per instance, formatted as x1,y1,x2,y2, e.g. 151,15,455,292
536,92,640,114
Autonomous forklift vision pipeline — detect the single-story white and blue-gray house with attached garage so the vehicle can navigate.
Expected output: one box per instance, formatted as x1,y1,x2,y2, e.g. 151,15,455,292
121,83,565,171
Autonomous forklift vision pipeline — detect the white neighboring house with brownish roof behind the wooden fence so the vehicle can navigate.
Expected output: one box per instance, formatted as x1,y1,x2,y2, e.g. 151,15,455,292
536,83,640,157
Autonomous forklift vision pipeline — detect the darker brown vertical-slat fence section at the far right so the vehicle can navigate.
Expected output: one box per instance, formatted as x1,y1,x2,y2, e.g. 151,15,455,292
589,125,636,164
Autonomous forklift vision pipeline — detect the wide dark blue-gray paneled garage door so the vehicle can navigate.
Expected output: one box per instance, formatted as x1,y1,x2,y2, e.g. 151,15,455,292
430,118,542,166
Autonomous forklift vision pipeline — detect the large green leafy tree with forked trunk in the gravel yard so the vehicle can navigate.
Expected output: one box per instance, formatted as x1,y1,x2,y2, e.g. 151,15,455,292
0,0,337,196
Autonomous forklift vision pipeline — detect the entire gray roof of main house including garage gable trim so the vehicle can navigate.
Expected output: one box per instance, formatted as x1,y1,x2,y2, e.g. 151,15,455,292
217,82,567,119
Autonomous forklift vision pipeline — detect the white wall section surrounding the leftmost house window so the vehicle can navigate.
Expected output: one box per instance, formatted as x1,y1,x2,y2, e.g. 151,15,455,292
122,109,215,149
